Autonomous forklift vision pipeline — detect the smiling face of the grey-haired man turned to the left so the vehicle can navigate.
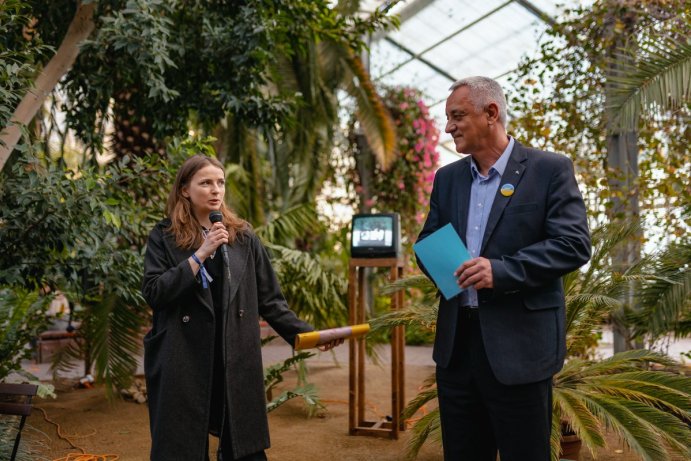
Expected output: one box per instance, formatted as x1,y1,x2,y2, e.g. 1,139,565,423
445,86,490,154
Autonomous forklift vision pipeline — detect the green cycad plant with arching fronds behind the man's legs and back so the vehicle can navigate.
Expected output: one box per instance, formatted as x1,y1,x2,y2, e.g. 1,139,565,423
373,222,691,461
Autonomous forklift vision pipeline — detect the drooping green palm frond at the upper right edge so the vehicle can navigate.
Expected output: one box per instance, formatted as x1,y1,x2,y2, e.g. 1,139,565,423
608,36,691,131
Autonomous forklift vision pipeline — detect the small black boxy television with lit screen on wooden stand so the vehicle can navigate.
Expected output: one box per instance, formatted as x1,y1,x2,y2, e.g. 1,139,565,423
350,213,401,258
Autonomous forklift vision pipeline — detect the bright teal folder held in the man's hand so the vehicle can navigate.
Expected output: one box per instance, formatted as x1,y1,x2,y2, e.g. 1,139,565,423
413,223,470,300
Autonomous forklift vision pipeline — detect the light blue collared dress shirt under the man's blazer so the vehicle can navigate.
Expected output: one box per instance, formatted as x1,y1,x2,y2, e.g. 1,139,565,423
460,136,514,307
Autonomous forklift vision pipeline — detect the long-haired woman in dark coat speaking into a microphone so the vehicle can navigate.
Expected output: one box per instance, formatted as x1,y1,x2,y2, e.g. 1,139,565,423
142,155,342,461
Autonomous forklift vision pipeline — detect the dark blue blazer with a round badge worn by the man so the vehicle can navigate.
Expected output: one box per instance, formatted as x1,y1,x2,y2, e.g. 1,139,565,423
418,142,590,385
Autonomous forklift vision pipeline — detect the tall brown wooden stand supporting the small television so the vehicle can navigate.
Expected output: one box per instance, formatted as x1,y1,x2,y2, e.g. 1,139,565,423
348,258,405,439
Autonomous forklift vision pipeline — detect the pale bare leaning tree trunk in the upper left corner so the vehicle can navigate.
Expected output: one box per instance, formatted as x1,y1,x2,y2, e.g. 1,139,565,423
0,2,96,171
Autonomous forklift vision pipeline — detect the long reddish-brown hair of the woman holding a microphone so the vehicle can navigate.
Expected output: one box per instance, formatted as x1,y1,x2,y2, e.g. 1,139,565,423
166,154,250,249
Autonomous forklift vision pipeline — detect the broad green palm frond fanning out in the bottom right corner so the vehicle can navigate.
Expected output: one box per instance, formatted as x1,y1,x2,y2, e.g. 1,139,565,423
554,350,691,459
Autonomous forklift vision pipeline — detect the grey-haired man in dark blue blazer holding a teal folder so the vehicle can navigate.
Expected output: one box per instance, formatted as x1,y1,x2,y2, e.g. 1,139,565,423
418,77,590,461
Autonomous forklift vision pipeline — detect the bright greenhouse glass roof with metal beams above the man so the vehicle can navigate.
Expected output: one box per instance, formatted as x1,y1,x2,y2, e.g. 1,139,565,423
361,0,592,163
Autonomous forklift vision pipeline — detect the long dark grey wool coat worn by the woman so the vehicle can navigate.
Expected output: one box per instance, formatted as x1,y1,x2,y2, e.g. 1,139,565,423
142,219,313,461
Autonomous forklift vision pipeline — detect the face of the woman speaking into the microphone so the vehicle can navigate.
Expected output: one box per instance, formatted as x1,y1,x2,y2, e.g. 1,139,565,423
182,165,226,221
